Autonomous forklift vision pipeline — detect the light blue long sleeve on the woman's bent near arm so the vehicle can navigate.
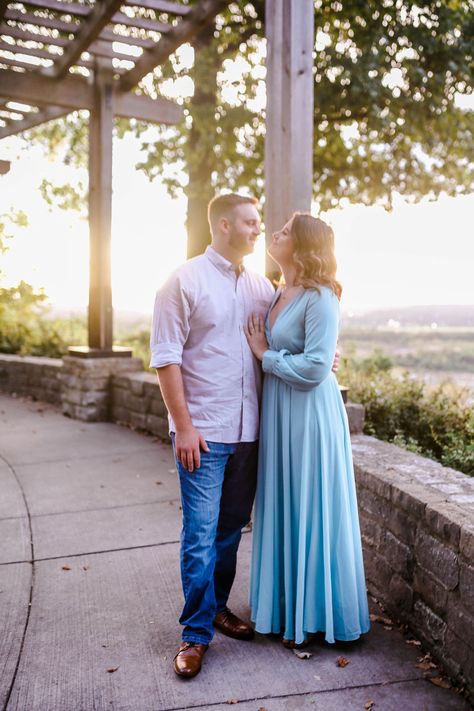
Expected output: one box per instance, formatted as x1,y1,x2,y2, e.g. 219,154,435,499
262,288,339,390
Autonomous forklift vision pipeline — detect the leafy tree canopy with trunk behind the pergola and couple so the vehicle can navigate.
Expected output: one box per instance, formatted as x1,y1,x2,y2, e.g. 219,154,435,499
20,0,474,254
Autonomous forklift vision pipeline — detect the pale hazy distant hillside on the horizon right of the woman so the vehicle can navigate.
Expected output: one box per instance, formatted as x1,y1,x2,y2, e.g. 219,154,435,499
342,305,474,328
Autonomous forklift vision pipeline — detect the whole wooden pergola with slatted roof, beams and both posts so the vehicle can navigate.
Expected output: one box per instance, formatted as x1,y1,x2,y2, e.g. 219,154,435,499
0,0,314,356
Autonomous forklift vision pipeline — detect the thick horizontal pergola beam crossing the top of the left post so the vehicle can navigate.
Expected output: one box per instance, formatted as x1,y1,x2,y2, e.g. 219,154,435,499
0,68,183,124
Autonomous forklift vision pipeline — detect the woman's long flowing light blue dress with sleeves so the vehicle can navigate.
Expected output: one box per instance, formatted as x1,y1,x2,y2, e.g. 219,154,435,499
250,287,370,643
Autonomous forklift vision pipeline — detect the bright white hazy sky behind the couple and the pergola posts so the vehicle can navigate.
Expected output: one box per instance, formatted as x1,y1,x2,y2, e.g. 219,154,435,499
0,127,474,313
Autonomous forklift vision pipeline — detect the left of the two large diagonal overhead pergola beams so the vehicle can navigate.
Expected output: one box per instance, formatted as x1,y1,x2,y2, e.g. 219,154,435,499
44,0,122,79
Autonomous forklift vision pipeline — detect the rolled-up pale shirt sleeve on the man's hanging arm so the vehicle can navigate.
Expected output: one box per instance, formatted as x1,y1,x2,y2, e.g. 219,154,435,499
150,274,191,368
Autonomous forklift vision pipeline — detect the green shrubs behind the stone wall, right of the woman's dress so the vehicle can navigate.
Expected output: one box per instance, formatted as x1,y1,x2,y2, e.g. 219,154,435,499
340,352,474,476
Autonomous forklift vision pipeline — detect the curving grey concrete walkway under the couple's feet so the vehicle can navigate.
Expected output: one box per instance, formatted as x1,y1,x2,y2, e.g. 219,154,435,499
0,396,469,711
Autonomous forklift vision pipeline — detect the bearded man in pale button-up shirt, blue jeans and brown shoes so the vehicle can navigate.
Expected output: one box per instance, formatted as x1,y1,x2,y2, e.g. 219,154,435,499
150,194,274,678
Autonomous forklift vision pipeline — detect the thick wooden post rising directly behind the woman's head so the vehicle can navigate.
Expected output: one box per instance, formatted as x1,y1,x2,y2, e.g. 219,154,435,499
265,0,314,277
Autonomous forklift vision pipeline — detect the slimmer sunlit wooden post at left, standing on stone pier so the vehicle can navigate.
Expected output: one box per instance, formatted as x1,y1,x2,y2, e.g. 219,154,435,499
89,59,114,352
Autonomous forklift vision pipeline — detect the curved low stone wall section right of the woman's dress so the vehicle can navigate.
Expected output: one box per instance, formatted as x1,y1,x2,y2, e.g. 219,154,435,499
353,435,474,700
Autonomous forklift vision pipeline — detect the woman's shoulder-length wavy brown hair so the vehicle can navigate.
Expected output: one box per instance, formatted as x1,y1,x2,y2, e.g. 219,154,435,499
291,212,342,299
